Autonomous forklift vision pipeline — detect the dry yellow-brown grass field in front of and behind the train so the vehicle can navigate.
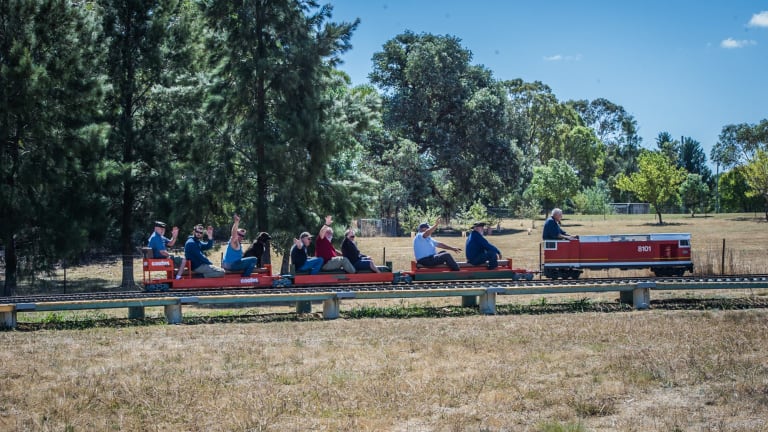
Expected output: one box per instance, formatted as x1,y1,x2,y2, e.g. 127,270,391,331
0,215,768,432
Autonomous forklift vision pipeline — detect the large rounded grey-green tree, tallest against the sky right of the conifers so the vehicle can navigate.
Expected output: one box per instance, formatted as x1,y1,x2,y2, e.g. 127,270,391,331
369,32,519,211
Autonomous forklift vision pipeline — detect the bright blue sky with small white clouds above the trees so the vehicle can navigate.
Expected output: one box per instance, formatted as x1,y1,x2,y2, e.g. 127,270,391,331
327,0,768,163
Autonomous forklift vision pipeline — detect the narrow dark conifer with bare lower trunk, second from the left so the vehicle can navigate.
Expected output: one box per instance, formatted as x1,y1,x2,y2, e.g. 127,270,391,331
98,0,201,287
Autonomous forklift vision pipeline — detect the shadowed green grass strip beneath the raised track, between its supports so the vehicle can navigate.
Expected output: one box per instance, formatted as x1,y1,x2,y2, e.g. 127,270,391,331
6,295,768,332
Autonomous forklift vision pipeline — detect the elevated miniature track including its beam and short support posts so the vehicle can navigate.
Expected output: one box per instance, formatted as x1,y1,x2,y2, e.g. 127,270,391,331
0,275,768,328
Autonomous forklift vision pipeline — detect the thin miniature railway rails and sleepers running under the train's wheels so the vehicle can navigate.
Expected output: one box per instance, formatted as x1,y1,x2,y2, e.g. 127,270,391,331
0,275,768,304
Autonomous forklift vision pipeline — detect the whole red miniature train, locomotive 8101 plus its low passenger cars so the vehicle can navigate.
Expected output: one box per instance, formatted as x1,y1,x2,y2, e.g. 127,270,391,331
142,234,693,291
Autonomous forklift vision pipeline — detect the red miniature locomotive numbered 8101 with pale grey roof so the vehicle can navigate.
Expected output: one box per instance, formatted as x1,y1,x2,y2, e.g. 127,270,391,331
541,233,693,279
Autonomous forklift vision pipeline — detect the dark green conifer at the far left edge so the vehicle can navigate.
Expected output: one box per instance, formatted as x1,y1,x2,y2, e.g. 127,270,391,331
0,0,104,296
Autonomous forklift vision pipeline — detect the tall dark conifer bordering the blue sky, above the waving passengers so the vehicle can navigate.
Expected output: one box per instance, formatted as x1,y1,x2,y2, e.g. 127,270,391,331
202,0,357,236
